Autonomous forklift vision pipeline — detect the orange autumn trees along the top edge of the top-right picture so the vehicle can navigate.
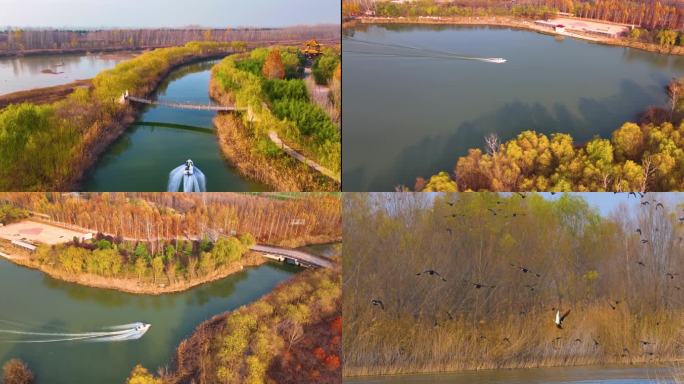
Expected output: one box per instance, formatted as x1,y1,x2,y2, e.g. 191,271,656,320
342,0,684,45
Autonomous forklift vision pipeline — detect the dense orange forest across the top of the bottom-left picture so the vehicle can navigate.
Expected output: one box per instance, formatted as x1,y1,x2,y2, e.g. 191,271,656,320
0,192,341,246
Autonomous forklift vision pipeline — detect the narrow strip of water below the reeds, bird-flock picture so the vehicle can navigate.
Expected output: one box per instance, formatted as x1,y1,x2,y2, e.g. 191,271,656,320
344,366,676,384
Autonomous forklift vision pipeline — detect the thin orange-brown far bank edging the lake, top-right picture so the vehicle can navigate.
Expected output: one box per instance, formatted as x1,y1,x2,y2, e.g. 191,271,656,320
343,16,684,56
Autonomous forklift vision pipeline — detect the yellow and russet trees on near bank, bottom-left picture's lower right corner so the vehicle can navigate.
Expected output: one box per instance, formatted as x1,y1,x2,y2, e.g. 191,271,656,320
127,269,342,384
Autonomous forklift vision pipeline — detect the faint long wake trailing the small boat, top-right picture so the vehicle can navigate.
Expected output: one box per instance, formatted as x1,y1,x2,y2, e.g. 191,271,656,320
344,38,508,64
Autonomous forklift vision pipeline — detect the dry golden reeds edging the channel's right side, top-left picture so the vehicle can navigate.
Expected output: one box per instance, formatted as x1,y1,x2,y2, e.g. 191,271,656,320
209,76,339,192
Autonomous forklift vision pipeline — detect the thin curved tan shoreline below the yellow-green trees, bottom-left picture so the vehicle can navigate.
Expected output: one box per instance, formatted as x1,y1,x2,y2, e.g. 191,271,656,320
0,237,335,296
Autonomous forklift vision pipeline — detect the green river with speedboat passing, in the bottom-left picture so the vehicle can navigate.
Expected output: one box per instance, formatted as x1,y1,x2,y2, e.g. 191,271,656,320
0,245,336,384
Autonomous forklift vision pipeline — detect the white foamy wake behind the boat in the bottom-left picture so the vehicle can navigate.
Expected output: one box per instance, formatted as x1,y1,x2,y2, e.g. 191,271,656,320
0,323,151,344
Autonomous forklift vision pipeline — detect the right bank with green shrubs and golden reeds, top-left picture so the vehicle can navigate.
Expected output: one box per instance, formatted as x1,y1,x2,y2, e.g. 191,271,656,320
211,48,341,191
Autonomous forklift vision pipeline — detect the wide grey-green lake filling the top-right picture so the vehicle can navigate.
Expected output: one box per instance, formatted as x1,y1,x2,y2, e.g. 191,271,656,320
342,25,684,191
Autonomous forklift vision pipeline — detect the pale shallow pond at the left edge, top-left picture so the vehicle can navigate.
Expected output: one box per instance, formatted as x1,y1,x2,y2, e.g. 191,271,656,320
0,52,134,95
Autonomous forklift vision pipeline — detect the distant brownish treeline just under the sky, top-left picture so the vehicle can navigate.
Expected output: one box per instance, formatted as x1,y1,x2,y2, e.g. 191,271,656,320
0,25,339,55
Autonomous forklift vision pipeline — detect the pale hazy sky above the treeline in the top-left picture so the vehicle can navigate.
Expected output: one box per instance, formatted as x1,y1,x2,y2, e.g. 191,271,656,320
0,0,340,28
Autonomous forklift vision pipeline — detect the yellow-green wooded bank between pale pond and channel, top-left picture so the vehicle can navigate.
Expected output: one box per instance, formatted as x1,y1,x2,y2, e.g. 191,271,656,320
0,43,244,191
